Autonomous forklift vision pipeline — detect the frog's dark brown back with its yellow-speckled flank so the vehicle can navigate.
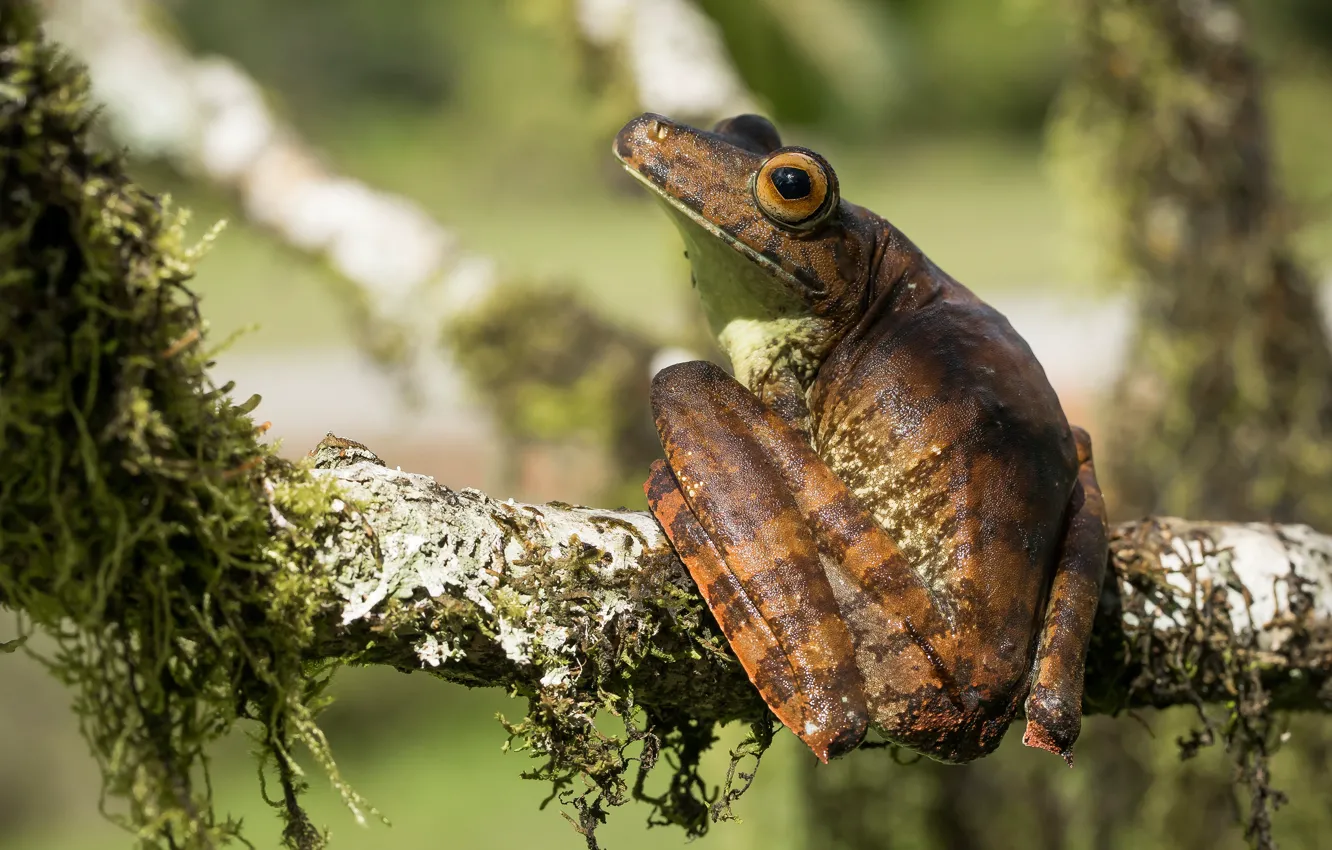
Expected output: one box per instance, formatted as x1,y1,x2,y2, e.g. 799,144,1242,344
810,268,1078,655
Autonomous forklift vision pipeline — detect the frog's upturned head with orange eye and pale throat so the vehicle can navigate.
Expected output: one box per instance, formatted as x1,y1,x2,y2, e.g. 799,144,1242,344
614,113,884,389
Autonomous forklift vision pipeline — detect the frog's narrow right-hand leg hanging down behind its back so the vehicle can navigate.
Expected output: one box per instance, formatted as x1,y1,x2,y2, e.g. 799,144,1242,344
1022,428,1108,766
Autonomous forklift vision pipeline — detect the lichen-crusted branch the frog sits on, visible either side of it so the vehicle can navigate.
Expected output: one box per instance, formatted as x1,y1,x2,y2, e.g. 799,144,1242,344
306,438,1332,721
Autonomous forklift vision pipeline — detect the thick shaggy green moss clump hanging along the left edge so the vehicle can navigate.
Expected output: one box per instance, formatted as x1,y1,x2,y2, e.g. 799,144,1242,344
0,9,375,847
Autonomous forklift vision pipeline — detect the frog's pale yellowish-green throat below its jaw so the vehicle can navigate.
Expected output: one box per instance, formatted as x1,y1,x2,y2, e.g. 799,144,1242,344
667,204,833,396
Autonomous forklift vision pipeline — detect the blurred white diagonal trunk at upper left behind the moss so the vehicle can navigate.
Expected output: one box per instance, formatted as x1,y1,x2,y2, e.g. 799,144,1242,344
45,0,497,397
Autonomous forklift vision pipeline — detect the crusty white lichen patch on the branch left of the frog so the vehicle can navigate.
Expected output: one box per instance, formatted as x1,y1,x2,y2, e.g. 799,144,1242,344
329,464,667,687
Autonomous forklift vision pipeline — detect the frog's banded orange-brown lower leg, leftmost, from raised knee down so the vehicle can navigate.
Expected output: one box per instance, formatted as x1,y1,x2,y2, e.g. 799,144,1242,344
645,362,868,761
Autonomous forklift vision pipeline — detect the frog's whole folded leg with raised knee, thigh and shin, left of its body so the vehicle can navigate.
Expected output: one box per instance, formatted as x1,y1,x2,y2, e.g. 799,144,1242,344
647,362,991,761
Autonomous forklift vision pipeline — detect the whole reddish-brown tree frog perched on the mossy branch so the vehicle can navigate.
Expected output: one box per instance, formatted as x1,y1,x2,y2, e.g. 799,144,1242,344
614,115,1106,762
